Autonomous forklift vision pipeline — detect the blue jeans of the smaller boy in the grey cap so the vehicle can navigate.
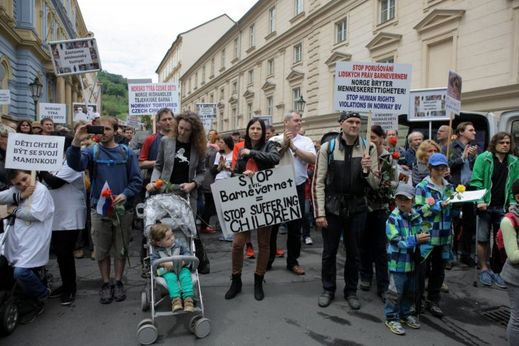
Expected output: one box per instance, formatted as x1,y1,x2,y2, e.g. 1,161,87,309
384,272,417,321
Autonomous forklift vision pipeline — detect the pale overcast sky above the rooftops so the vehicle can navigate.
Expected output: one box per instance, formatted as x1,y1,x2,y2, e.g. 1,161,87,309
78,0,256,82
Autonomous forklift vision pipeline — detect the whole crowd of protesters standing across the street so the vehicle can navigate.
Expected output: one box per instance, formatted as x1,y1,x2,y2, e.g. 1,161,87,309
0,109,519,344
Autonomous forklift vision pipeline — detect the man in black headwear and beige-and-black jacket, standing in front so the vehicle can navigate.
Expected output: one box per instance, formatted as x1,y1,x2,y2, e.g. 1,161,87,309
312,112,378,310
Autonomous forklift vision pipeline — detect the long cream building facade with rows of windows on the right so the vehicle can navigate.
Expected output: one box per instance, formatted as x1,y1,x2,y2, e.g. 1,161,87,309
181,0,519,137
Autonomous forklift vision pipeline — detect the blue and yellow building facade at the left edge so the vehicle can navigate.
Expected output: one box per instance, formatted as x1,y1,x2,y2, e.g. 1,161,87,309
0,0,101,123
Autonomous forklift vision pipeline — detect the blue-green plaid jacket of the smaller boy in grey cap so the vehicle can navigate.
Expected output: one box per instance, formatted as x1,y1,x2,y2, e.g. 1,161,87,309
386,208,423,273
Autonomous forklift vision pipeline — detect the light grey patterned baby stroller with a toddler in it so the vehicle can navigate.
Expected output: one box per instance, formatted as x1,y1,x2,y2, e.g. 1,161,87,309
137,194,211,345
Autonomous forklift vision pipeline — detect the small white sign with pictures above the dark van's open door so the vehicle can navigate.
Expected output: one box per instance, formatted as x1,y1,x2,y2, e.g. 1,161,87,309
407,88,449,121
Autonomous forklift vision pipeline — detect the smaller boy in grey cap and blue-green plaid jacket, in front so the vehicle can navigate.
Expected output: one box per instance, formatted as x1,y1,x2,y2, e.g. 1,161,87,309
384,184,430,335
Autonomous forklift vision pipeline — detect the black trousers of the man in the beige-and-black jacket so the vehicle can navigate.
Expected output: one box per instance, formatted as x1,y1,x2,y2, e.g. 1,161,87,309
321,212,367,296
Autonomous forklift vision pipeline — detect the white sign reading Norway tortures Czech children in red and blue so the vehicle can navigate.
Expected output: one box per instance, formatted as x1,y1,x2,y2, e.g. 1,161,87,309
128,83,180,115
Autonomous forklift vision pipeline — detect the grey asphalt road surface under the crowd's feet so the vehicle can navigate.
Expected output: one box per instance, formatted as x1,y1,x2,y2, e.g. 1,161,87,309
0,227,508,346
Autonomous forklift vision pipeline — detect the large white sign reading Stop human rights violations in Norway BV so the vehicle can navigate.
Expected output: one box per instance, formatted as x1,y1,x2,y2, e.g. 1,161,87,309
335,61,412,114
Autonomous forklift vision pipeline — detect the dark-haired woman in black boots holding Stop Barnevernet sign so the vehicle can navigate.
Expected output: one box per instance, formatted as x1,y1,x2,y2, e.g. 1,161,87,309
225,118,280,300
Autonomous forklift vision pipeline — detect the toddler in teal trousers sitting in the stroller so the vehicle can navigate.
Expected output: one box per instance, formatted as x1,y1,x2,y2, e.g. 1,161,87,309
150,224,194,312
